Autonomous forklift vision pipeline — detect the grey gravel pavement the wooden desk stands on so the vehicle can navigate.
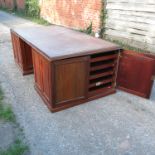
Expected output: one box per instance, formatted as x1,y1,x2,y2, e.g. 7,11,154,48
0,12,155,155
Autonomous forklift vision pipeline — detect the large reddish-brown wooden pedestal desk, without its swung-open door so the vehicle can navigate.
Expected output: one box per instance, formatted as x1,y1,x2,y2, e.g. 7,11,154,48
11,26,120,112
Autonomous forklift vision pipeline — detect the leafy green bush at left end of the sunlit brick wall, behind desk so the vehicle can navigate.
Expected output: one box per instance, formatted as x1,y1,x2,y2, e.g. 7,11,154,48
25,0,40,18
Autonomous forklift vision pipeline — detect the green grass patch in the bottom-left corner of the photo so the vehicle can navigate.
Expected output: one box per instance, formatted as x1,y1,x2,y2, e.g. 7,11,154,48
0,140,28,155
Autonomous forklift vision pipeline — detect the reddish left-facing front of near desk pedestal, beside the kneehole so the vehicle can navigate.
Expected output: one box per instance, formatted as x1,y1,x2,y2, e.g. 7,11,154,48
32,49,52,102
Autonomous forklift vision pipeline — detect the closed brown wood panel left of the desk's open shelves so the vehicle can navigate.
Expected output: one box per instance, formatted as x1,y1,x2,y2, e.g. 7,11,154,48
54,57,88,105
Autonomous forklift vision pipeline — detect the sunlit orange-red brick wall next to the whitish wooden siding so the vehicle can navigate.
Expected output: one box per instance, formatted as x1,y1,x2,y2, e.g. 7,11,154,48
40,0,102,32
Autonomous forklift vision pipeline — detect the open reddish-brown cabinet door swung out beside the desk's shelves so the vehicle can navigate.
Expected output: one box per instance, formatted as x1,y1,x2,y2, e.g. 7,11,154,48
117,51,155,98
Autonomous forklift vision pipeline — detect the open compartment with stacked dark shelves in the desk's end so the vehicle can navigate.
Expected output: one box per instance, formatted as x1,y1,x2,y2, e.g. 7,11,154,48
88,51,119,97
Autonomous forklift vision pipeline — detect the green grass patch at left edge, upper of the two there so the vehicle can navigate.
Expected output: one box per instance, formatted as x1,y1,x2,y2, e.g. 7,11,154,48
0,88,15,122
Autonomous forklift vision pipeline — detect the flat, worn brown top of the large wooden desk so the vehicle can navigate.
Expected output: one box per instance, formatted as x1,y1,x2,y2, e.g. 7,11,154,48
11,26,120,60
